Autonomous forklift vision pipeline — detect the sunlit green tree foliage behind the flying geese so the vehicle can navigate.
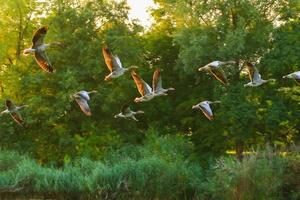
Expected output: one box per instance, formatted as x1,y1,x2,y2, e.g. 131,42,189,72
0,0,300,165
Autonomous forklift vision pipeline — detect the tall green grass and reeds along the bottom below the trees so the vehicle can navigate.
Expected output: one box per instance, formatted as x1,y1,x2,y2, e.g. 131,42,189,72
0,136,300,200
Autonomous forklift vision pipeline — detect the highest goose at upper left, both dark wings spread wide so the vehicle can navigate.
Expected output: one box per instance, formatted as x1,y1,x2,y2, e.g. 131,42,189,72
23,26,61,73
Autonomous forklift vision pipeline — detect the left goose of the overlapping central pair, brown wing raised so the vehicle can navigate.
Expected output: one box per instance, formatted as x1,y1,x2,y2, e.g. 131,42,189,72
131,71,155,103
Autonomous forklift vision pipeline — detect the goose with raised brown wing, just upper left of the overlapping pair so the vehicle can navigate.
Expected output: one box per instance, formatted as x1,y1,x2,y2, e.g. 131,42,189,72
102,46,138,81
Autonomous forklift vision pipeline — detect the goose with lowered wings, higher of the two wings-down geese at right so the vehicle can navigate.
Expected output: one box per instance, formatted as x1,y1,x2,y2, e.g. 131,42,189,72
198,61,236,85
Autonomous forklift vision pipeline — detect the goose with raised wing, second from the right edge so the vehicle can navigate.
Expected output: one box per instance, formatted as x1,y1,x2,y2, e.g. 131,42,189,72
244,62,275,87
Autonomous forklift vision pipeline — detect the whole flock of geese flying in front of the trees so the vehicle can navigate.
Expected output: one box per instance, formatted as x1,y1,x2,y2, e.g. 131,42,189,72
0,26,300,125
